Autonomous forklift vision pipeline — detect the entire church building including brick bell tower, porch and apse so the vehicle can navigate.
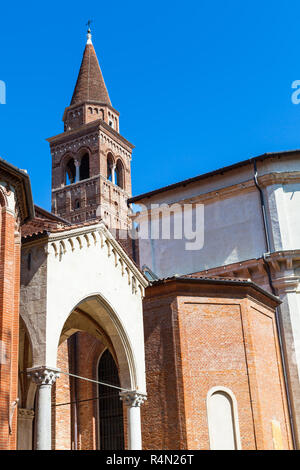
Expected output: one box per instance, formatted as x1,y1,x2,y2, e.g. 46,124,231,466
0,31,300,450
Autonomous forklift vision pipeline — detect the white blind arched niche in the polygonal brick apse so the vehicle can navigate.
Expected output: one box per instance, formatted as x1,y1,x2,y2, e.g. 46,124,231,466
207,387,241,450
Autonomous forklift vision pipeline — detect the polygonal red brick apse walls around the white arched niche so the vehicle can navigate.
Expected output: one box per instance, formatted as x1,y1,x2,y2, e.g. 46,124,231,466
142,282,292,450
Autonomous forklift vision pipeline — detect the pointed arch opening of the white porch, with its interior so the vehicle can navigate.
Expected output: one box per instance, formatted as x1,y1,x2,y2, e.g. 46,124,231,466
48,295,146,450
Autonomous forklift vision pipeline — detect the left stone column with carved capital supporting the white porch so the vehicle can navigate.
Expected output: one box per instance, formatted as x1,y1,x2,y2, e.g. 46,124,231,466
27,366,60,450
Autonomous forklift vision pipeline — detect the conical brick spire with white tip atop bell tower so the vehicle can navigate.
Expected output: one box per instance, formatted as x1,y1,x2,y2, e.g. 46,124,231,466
71,29,111,106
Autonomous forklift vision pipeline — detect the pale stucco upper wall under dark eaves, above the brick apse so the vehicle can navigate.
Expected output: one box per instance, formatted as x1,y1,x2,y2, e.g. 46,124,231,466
137,156,300,277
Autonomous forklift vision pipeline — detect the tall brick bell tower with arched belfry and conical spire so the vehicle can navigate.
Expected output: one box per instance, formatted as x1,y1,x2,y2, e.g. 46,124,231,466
47,29,134,230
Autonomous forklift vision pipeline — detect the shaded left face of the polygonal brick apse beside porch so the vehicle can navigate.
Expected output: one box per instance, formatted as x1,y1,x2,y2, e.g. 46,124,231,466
141,289,186,450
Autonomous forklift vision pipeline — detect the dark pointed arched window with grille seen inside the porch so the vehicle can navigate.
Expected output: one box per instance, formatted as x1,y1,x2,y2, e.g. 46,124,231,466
98,349,124,450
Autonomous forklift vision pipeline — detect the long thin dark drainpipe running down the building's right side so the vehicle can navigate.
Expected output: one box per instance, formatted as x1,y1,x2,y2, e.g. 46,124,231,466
253,159,297,449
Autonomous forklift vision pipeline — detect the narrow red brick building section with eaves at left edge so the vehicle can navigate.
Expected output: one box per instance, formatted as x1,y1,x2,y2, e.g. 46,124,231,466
0,158,34,450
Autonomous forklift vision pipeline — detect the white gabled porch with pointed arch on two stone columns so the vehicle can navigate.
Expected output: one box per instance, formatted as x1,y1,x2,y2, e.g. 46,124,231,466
21,222,147,449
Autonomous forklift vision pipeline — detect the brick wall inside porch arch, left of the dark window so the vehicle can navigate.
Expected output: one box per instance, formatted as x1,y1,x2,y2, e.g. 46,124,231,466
52,332,127,450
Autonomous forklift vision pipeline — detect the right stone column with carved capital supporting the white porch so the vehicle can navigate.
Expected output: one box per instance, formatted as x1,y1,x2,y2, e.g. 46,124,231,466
120,390,147,450
